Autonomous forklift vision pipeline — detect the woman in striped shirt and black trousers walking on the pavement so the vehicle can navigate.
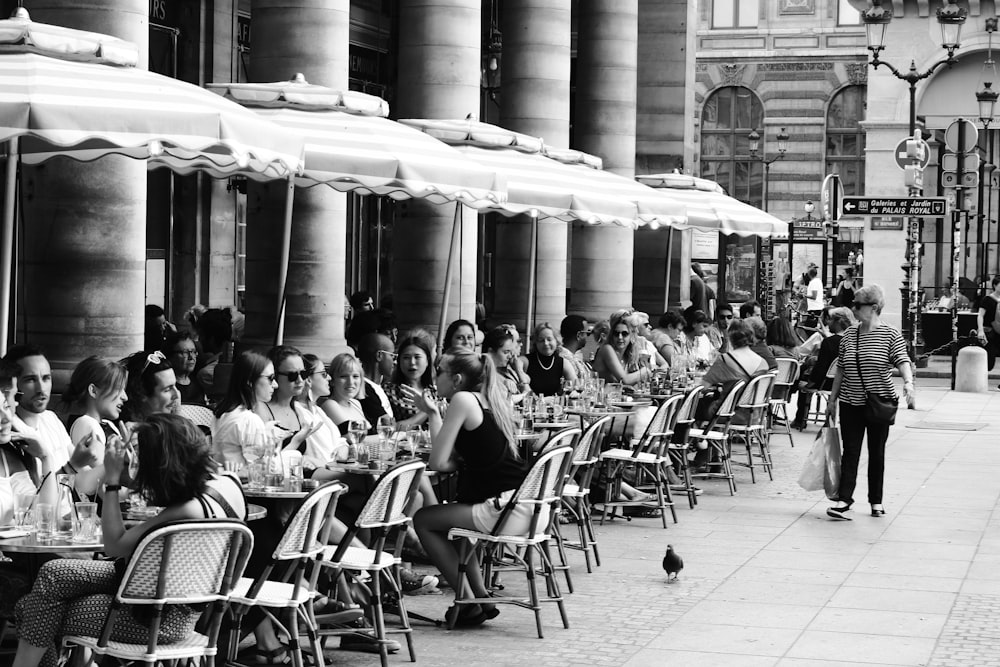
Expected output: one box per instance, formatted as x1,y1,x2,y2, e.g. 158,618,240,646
826,285,913,521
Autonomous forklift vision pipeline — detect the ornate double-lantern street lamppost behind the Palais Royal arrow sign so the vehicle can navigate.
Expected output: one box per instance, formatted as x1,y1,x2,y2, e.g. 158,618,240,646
861,0,968,361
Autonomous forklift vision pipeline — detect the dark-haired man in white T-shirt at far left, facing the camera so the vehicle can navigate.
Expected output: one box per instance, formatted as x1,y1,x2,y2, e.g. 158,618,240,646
3,344,98,474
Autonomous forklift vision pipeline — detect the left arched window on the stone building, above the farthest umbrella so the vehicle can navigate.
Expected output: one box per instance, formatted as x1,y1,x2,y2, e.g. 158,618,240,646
701,86,764,207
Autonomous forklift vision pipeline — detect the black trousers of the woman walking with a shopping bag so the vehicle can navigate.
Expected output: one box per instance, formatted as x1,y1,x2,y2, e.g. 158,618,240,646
837,402,889,505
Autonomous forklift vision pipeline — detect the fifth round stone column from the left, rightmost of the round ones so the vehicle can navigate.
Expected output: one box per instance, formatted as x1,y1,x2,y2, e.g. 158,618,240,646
569,0,639,319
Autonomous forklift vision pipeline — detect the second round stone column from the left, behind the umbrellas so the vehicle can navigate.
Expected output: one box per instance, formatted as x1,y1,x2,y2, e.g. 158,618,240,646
245,0,350,358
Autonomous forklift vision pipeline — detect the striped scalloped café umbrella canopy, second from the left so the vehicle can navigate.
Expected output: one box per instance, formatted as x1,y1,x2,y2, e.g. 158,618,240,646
207,79,505,209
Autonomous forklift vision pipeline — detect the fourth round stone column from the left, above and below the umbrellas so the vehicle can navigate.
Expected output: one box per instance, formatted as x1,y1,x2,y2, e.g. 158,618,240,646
493,0,572,328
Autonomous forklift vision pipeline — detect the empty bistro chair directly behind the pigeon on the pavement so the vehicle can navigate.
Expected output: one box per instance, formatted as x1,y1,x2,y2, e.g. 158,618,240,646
600,394,684,528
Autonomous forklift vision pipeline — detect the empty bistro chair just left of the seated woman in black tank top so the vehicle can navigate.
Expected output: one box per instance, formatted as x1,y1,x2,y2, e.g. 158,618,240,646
319,461,427,667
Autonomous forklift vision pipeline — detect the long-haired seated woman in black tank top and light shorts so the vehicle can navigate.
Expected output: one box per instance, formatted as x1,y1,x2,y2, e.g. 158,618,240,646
406,348,527,627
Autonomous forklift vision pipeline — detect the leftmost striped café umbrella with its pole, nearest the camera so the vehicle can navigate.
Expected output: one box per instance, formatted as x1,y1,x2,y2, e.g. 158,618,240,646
0,9,303,350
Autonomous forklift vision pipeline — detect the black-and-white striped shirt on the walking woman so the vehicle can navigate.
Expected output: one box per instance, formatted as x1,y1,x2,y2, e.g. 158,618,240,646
838,324,910,405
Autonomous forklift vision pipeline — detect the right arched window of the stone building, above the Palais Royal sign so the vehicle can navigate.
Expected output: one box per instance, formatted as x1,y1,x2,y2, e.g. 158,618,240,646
826,86,867,195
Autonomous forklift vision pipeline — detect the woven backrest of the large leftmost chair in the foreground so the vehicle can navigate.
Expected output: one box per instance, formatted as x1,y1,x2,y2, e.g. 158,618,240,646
117,519,253,604
